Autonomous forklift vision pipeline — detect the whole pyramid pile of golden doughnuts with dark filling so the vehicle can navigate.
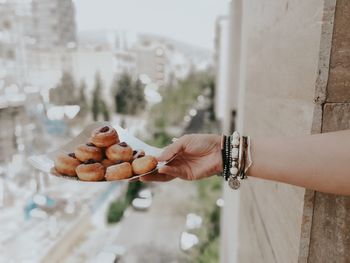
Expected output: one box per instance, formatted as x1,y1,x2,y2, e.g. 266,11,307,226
55,126,158,181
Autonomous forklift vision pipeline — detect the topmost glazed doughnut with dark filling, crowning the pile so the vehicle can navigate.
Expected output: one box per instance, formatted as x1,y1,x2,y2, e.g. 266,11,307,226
90,126,119,147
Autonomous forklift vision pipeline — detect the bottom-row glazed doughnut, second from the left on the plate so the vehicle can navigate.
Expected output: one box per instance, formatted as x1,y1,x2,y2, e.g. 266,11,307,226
76,160,105,181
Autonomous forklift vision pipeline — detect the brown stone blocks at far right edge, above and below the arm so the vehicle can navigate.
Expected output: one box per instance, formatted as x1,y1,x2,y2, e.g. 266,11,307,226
303,0,350,263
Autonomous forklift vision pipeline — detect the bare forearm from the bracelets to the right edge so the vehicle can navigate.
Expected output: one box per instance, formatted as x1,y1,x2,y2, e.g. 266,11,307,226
248,131,350,195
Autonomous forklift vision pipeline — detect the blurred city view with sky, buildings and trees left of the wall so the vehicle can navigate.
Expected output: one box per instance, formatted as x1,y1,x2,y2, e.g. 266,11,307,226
0,0,228,263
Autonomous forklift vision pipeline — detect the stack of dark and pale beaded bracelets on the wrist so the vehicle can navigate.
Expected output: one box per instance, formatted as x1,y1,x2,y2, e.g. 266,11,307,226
221,131,252,189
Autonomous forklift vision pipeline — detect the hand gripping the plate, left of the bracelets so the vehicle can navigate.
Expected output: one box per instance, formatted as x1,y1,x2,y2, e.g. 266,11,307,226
140,134,222,181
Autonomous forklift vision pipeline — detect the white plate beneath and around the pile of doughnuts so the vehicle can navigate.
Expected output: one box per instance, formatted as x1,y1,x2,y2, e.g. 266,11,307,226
28,122,175,183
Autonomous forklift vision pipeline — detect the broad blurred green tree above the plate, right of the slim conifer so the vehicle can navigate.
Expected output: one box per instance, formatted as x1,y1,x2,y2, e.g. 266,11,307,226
112,73,146,115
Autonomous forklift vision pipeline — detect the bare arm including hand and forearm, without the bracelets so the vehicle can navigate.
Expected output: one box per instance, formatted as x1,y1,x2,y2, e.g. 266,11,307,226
142,130,350,195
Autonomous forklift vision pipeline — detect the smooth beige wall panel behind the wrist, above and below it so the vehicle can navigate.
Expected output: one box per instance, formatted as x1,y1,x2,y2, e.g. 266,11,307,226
238,0,323,263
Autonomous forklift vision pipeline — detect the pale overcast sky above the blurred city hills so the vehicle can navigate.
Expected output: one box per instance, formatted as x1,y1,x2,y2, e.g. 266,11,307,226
74,0,229,49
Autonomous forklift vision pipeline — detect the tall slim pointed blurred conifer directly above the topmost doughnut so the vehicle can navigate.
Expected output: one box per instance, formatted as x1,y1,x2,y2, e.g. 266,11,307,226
91,72,110,121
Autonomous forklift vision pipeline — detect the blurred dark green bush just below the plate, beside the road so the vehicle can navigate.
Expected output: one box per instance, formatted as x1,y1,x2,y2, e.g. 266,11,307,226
107,181,143,224
